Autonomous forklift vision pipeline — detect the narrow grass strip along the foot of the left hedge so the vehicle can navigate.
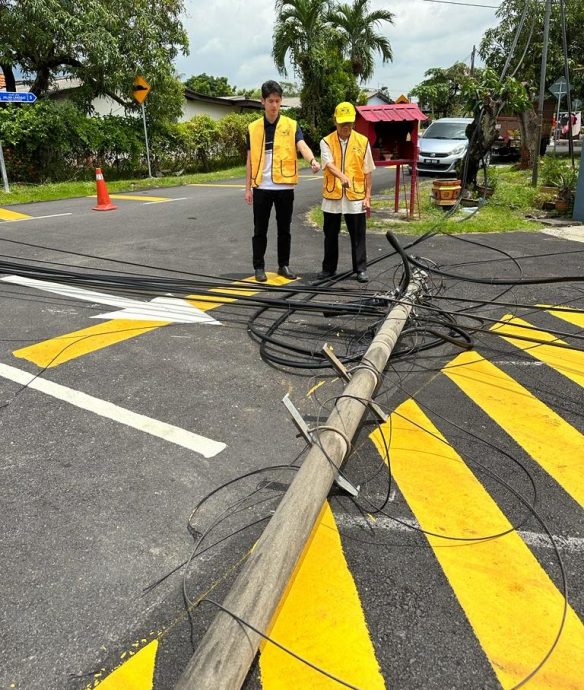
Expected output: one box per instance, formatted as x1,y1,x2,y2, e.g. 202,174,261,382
0,165,245,206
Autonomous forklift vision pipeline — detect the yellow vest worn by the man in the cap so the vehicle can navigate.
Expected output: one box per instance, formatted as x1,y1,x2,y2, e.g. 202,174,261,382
322,132,368,201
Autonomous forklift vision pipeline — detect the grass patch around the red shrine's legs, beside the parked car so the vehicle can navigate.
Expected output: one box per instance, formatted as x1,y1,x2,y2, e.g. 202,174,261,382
309,166,543,235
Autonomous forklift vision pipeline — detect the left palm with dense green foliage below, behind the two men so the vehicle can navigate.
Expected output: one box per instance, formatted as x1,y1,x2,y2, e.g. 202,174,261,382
272,0,359,139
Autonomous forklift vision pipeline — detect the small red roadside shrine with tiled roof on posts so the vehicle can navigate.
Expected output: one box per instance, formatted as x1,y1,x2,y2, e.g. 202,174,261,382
355,103,428,218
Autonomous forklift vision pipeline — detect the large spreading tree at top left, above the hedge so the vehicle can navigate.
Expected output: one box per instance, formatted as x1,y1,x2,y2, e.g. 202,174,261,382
0,0,188,117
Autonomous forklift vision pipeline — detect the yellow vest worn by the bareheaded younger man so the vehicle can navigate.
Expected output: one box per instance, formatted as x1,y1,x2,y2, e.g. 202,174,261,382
248,115,298,187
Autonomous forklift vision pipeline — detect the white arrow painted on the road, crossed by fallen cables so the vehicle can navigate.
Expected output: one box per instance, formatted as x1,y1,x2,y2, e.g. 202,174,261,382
0,276,221,326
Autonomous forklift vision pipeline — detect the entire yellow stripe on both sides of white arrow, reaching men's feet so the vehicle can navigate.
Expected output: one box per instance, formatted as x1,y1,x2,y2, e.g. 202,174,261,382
12,273,291,367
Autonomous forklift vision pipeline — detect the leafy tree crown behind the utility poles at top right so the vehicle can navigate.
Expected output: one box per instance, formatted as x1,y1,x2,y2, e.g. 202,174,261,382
479,0,584,103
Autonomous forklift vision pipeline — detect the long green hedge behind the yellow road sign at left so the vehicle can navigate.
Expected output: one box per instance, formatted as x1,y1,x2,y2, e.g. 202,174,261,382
0,100,258,182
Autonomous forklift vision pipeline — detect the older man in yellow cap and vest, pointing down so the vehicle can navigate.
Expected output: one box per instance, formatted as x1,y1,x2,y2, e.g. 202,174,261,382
317,102,375,283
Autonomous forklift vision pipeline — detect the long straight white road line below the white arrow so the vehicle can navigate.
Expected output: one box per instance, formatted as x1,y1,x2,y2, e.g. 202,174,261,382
0,364,227,458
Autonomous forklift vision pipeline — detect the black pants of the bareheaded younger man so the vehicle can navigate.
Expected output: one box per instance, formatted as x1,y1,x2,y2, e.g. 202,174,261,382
252,188,294,270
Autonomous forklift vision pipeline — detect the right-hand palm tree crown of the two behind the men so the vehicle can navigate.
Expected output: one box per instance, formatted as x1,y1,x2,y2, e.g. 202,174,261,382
328,0,394,82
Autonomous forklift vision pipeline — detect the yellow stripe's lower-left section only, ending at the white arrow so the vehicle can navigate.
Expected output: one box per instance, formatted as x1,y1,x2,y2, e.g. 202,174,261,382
12,319,164,368
